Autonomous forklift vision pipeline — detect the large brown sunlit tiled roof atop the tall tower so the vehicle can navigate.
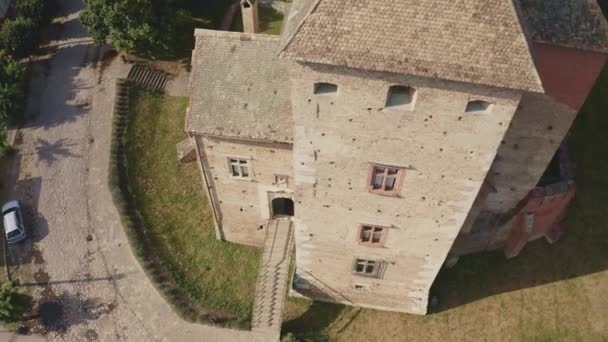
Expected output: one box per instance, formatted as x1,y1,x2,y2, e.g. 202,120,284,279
280,0,549,92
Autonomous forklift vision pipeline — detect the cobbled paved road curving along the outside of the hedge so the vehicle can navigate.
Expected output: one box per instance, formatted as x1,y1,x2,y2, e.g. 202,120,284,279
0,0,267,341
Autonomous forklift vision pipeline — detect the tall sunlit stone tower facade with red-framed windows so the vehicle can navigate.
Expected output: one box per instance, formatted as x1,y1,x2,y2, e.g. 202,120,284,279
291,63,520,313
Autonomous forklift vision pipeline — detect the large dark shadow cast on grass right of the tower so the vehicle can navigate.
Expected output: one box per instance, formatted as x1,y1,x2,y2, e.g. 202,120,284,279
431,69,608,311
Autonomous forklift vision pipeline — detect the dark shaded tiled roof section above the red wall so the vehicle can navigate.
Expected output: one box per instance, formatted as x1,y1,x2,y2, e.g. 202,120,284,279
519,0,608,52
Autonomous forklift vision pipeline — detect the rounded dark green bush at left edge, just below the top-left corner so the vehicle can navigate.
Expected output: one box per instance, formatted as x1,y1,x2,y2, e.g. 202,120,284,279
0,17,36,58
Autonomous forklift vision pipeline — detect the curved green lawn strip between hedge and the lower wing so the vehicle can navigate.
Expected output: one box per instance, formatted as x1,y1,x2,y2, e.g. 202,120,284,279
127,91,259,318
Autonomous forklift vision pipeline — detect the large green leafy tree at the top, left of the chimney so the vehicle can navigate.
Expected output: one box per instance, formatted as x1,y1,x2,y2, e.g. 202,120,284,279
80,0,183,57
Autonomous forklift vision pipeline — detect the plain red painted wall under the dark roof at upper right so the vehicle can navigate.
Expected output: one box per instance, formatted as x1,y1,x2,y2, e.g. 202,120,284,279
532,43,608,111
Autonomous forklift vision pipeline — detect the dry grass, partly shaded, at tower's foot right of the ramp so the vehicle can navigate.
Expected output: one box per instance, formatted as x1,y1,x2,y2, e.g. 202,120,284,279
283,69,608,341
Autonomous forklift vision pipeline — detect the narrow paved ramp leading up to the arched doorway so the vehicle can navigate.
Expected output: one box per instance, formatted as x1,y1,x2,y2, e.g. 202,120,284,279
251,218,293,341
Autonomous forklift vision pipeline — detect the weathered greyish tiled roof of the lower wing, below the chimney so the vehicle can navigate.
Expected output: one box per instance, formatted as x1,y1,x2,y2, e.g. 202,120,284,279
186,30,293,143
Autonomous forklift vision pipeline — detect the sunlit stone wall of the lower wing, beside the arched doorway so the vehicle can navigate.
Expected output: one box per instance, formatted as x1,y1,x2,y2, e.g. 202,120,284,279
196,136,293,246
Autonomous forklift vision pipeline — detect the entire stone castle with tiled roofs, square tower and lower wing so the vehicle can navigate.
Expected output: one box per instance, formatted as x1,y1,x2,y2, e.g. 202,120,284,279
186,0,608,314
